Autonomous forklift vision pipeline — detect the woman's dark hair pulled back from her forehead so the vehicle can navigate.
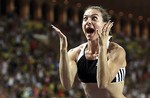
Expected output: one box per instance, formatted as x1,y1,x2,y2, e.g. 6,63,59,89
85,6,111,22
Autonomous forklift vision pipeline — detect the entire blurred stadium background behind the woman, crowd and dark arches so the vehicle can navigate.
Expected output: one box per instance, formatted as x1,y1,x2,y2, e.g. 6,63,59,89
0,0,150,98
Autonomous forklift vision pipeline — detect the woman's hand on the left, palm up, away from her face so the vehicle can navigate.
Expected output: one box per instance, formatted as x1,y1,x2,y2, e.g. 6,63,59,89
51,25,68,50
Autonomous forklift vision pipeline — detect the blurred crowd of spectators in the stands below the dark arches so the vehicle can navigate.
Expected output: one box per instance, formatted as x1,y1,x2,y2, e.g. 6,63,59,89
0,13,150,98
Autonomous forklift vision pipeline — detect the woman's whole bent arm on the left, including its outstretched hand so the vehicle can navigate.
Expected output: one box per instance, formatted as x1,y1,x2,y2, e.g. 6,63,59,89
52,26,77,89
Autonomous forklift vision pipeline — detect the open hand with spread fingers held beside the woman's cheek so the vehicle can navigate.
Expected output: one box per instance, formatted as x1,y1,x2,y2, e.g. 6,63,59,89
97,20,113,46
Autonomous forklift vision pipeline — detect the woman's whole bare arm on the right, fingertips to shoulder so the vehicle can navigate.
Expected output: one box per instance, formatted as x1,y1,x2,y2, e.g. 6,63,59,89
97,21,125,88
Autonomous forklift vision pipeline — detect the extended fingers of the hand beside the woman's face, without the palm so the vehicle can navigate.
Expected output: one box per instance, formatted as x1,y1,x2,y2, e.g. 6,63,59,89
102,20,114,36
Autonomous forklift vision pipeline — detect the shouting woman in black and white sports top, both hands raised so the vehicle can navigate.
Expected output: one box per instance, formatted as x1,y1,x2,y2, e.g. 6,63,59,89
52,6,126,98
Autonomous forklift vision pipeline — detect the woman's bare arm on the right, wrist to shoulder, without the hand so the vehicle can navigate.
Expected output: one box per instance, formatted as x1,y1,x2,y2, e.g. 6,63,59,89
97,44,126,88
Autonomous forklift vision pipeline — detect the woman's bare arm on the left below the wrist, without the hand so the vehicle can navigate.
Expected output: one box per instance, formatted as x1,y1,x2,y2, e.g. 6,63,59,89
59,50,77,89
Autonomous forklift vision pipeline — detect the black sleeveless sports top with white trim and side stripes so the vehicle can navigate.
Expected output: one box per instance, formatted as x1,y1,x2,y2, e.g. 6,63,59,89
77,43,126,83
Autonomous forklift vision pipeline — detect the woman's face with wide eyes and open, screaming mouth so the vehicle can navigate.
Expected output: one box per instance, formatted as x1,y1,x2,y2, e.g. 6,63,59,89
82,9,104,41
